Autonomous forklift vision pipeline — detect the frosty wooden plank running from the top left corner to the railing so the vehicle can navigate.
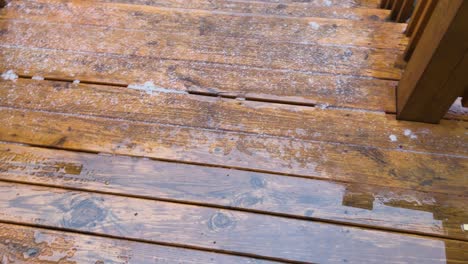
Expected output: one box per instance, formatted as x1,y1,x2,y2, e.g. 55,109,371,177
2,2,407,50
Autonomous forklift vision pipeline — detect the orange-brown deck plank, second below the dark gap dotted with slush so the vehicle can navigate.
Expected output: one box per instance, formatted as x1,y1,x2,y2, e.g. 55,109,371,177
0,108,468,195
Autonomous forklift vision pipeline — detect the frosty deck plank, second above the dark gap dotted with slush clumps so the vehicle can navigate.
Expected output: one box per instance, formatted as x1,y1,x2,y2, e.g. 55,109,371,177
0,20,401,79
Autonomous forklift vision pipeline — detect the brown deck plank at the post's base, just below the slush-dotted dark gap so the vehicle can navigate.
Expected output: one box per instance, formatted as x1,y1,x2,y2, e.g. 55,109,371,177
0,79,468,156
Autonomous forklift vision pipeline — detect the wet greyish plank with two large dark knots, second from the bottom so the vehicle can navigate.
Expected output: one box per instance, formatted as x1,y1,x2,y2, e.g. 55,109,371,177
0,183,468,263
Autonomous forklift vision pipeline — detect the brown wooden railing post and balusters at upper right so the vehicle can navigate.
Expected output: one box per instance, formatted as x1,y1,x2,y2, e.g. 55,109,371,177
381,0,468,123
